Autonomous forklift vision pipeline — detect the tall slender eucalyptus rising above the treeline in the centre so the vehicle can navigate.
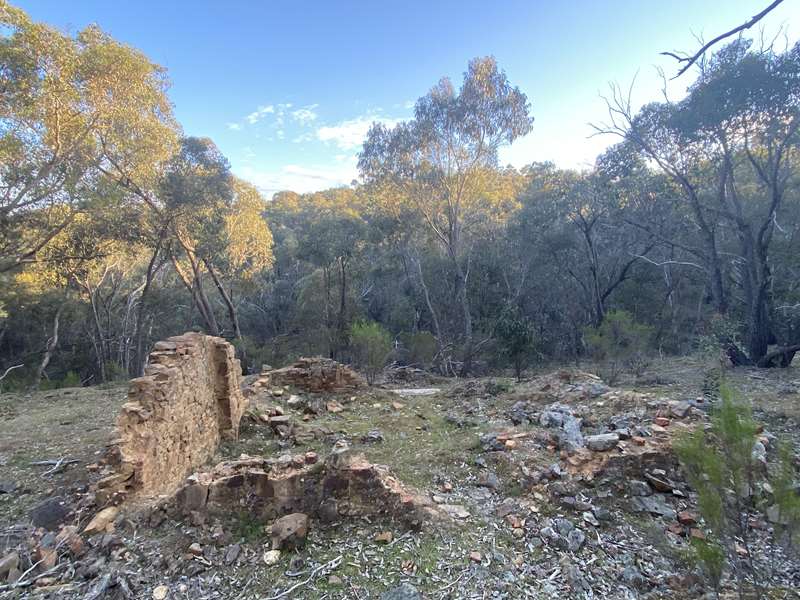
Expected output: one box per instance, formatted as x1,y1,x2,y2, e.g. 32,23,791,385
359,57,532,374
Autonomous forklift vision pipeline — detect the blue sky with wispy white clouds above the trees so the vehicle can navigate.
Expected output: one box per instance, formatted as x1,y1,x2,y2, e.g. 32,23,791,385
11,0,800,195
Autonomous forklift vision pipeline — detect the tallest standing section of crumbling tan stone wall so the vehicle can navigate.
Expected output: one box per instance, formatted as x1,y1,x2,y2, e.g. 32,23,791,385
97,333,246,504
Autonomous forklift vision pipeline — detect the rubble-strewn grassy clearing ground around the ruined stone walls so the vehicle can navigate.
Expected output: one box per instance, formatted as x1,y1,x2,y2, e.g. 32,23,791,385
0,359,800,600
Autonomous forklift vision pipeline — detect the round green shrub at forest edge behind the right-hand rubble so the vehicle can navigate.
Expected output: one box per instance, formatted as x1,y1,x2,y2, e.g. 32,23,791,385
584,310,653,384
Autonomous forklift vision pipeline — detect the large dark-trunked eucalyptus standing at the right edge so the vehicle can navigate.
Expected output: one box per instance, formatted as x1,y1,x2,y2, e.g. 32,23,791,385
680,40,800,366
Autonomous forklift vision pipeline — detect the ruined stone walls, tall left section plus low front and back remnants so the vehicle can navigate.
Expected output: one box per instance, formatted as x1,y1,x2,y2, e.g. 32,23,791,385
95,333,446,527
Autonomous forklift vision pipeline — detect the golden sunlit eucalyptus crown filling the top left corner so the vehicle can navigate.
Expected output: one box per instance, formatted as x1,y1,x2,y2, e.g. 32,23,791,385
0,0,177,271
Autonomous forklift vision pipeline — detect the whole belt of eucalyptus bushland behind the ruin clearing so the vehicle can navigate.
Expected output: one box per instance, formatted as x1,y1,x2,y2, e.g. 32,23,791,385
0,2,800,388
